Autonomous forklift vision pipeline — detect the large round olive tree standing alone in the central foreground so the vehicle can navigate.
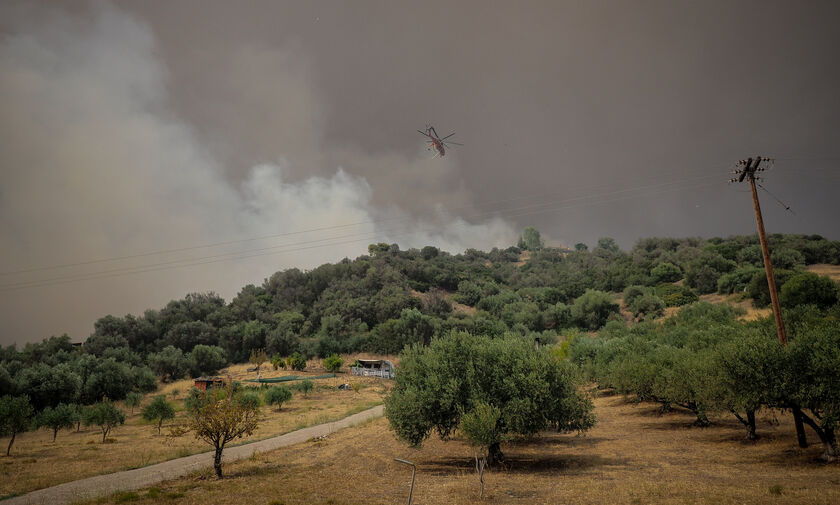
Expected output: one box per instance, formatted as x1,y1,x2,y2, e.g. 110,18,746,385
385,332,594,464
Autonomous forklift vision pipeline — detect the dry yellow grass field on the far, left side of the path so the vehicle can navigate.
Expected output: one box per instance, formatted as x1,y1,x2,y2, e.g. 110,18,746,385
0,356,390,497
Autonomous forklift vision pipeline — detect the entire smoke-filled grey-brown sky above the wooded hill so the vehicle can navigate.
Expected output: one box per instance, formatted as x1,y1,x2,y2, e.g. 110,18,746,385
0,0,840,344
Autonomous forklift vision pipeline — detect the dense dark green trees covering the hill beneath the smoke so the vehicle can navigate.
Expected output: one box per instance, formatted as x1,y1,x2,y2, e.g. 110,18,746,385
0,232,840,409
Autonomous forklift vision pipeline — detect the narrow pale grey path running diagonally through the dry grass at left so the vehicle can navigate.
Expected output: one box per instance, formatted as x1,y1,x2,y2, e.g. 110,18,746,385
2,405,384,505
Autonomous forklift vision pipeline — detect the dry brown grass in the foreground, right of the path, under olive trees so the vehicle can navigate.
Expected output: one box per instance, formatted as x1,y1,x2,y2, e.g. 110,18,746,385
80,390,840,505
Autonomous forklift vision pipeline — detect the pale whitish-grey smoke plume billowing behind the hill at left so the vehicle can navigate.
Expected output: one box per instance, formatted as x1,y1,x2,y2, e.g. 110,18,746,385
0,5,515,344
